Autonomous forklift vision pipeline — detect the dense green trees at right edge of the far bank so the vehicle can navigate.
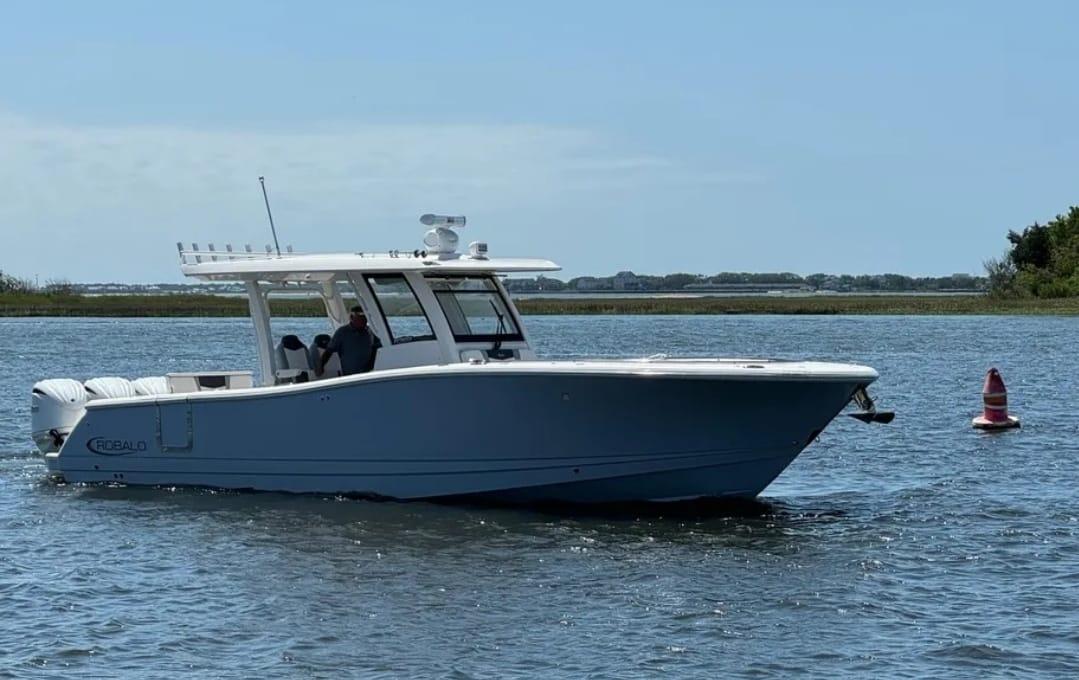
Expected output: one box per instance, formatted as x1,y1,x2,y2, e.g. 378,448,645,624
985,206,1079,298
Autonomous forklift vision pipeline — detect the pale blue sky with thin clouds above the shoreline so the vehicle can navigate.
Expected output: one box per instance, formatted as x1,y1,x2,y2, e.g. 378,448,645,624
0,1,1079,282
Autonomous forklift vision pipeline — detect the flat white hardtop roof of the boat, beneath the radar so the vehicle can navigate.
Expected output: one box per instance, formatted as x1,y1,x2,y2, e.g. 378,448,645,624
180,250,561,281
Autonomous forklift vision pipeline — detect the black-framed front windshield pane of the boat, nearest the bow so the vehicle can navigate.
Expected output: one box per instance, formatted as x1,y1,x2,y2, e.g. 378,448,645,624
427,275,523,342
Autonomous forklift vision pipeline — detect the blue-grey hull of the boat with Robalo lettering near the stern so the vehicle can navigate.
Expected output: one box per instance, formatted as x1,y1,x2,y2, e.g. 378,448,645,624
46,369,875,503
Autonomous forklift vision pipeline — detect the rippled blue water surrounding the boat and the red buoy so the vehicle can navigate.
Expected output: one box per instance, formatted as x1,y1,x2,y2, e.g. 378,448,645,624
0,316,1079,678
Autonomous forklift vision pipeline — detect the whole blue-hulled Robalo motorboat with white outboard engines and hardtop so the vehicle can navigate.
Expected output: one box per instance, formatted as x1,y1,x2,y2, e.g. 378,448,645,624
31,216,887,503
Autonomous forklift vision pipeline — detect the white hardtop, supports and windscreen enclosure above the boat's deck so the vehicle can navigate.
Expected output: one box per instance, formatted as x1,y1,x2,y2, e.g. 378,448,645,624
177,215,559,385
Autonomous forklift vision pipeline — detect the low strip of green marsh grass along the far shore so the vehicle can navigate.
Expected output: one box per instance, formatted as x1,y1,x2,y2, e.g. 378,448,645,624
0,293,1079,317
